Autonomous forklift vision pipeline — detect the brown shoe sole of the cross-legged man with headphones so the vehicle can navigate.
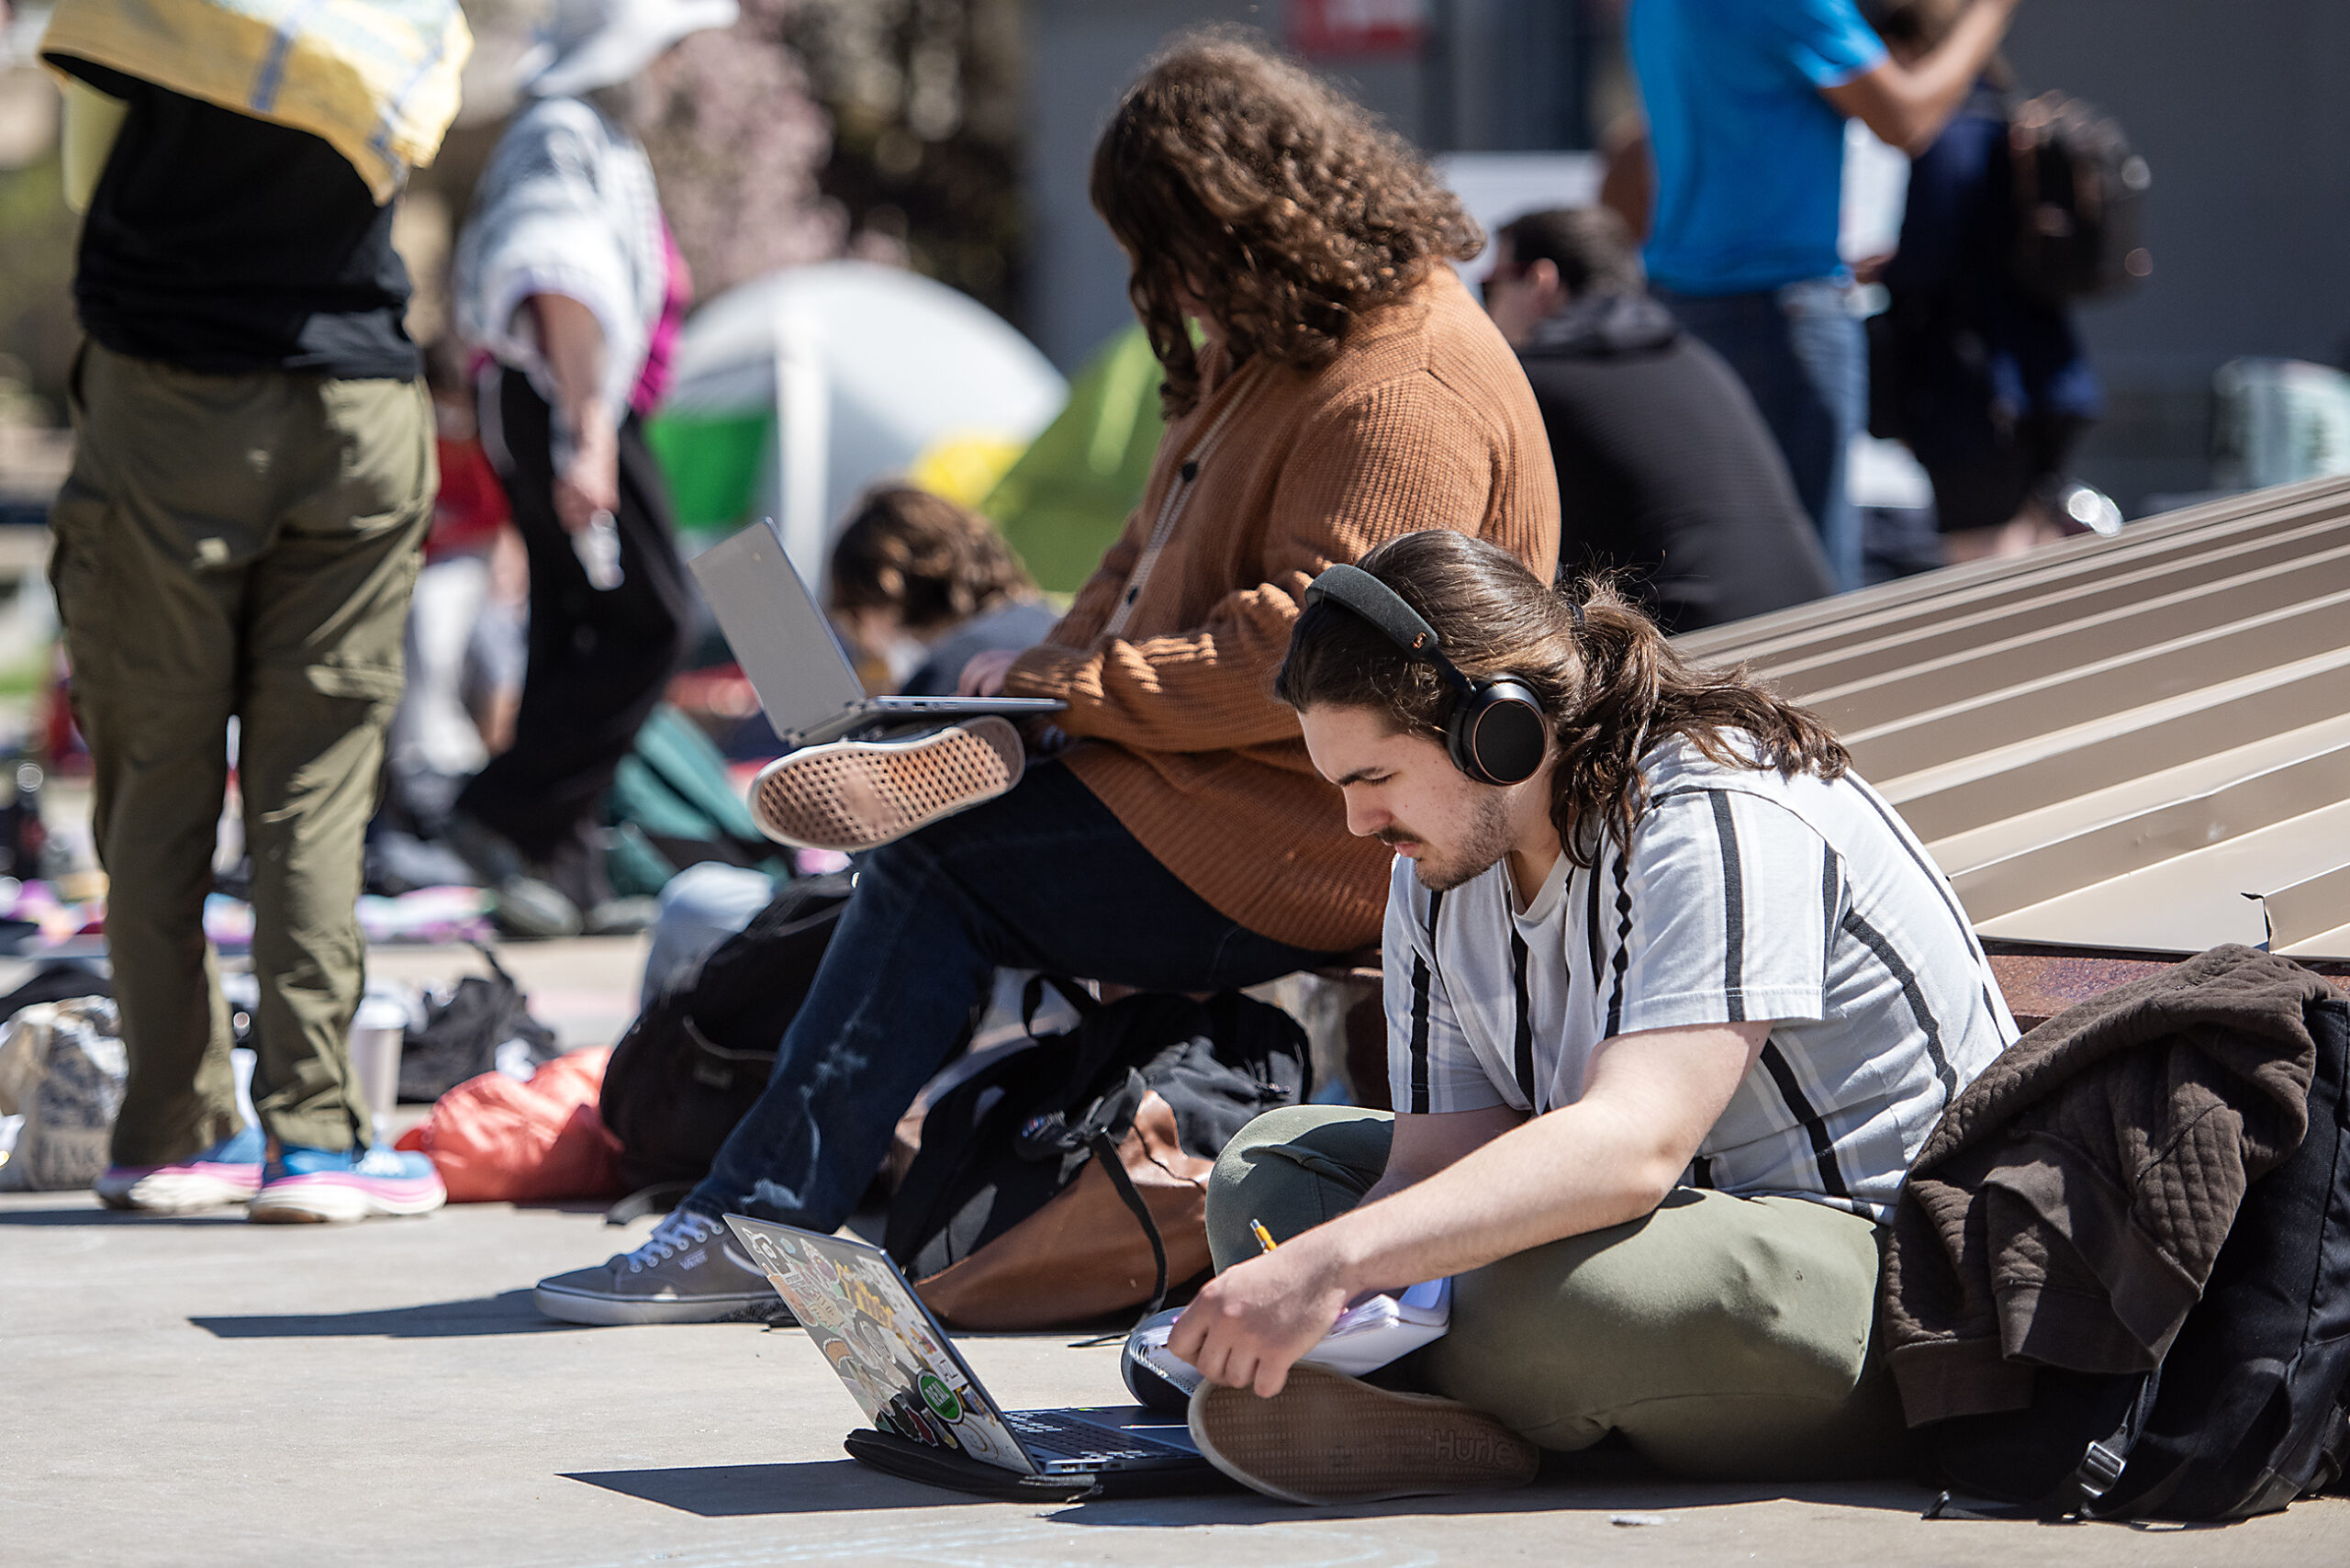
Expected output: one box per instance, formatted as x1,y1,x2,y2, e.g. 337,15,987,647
1192,1366,1541,1502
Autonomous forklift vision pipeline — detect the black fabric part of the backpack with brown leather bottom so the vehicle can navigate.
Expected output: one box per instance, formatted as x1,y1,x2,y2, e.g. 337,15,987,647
884,980,1311,1316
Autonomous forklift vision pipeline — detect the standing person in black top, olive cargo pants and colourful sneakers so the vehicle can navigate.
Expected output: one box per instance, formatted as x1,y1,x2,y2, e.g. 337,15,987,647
47,51,453,1220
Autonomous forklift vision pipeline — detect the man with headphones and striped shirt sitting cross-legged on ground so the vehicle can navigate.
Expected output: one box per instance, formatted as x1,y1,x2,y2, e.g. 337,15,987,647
1170,533,2016,1502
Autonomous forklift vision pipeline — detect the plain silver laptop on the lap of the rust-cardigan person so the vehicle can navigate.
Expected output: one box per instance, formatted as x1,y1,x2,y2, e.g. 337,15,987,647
691,520,1067,750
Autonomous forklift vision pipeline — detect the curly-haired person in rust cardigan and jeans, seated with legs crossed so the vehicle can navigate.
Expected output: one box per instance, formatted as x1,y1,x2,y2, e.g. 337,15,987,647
536,38,1558,1324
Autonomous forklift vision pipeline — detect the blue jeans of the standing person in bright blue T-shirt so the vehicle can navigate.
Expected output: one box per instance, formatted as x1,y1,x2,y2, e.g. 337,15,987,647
1657,277,1868,592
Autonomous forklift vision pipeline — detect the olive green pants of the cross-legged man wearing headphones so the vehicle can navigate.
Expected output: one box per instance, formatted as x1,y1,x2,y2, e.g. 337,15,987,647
1208,1105,1910,1481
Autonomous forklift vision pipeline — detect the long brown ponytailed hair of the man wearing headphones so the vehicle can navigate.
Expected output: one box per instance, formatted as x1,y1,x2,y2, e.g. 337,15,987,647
1274,529,1852,865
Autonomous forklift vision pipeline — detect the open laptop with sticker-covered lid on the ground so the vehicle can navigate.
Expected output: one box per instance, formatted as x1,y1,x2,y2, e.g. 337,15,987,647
726,1213,1213,1476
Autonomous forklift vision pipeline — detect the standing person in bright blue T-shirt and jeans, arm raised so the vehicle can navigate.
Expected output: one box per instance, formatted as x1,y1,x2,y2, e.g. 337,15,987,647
1631,0,2016,590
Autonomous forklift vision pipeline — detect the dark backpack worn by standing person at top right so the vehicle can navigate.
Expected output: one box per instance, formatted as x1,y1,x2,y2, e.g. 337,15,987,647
2007,92,2155,306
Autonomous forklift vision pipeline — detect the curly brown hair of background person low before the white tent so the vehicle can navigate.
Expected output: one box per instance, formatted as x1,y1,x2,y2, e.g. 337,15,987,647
832,485,1036,637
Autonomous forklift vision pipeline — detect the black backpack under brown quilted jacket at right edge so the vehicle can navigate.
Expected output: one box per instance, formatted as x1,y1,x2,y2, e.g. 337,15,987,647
1920,1002,2350,1521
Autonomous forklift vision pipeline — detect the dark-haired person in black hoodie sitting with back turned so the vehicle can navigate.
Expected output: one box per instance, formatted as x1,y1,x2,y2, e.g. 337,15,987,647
1485,207,1835,633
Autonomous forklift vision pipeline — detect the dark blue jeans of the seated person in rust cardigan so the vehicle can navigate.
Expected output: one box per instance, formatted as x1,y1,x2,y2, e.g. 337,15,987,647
684,762,1330,1232
